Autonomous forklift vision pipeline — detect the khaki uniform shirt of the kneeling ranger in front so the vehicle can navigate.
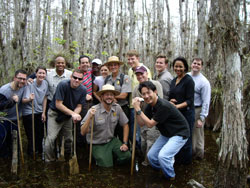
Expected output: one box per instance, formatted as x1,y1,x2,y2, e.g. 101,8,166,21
81,103,128,144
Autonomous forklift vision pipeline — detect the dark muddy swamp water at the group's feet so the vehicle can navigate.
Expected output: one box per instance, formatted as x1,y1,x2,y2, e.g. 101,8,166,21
0,130,218,188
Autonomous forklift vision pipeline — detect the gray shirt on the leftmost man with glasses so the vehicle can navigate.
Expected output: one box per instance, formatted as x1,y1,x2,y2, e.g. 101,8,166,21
0,83,24,121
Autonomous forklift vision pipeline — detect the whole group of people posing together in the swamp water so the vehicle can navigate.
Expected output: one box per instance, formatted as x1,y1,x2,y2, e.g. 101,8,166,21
0,50,211,179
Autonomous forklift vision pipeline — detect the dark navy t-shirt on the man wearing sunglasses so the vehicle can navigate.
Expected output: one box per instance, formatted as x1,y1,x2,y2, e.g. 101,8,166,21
50,80,87,112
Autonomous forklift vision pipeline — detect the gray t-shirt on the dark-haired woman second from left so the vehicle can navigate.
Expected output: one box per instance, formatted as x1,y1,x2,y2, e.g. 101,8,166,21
22,79,49,116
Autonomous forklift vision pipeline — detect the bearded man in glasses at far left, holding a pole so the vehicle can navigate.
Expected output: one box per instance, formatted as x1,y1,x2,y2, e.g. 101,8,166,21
0,69,27,158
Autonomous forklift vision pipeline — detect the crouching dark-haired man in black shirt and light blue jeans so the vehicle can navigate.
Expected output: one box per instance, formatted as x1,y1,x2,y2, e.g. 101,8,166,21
132,81,190,180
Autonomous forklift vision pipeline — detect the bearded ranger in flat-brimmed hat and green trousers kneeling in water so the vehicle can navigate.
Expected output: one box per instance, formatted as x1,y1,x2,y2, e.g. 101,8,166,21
81,84,131,167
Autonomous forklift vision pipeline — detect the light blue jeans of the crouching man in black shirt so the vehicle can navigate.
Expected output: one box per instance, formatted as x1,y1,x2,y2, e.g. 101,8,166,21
148,135,187,178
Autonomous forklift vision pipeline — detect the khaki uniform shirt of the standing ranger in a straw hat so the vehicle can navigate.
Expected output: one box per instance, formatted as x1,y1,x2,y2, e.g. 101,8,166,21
107,73,132,106
